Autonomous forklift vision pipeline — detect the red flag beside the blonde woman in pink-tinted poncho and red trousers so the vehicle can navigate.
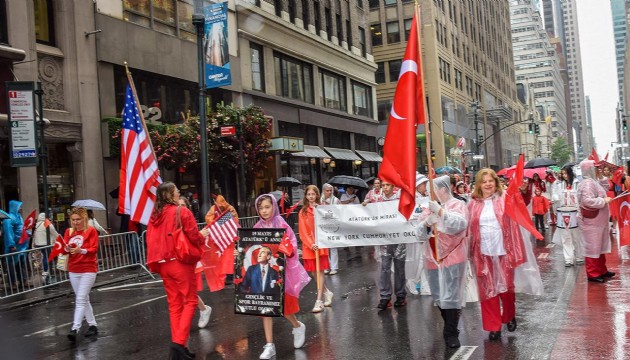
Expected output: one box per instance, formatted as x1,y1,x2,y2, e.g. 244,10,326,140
505,154,544,240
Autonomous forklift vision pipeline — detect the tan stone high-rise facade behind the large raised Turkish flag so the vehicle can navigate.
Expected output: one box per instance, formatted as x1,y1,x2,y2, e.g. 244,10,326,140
369,0,522,170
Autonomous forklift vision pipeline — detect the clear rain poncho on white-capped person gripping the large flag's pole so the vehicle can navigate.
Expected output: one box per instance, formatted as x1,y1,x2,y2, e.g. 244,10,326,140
417,175,468,309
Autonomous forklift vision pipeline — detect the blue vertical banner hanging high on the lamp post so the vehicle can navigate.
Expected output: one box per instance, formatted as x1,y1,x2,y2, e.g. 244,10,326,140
204,2,232,89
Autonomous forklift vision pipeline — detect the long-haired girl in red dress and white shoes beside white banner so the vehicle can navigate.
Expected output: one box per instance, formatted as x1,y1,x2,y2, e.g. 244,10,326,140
298,185,333,313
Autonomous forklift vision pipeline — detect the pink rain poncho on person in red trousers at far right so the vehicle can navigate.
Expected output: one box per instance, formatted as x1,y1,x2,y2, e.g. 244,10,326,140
578,160,610,259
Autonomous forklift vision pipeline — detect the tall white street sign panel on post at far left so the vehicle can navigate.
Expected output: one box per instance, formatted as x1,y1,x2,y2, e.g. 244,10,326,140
6,81,37,167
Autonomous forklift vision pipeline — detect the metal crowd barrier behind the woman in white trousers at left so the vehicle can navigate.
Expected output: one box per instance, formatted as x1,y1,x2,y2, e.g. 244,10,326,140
0,232,153,299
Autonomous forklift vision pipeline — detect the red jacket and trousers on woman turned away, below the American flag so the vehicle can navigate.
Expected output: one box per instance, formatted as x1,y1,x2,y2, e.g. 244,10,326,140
147,204,204,346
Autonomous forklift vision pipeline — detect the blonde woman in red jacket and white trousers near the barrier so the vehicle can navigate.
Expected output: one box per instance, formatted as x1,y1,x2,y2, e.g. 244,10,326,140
63,208,98,342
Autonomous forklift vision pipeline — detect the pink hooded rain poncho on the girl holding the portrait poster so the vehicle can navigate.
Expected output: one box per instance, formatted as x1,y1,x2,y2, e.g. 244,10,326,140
254,194,311,298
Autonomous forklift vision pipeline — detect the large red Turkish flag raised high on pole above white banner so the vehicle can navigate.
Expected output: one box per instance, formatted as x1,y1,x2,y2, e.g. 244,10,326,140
378,15,425,219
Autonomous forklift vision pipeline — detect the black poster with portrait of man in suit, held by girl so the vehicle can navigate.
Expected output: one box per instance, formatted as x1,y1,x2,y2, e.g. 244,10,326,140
234,228,285,317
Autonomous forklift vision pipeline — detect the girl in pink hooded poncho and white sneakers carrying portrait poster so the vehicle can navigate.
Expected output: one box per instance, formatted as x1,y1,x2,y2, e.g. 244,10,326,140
254,194,311,359
